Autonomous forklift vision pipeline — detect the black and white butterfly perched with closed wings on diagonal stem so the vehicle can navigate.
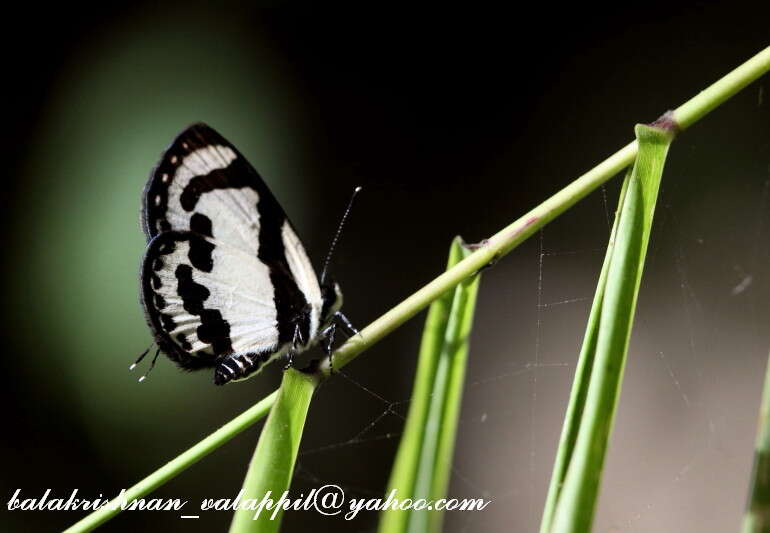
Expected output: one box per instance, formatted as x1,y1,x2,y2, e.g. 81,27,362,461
136,124,356,385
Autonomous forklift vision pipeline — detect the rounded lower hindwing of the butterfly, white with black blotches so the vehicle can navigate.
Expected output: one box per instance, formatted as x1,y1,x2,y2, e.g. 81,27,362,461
142,231,278,368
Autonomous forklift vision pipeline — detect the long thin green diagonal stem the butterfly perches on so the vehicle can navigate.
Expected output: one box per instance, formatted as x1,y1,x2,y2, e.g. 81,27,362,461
67,47,770,532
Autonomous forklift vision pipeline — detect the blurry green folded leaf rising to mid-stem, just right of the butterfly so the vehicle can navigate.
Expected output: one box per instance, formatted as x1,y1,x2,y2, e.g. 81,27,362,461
378,237,479,533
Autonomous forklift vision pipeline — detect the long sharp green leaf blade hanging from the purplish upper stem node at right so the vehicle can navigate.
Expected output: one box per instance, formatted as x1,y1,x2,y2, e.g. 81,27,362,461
541,125,673,533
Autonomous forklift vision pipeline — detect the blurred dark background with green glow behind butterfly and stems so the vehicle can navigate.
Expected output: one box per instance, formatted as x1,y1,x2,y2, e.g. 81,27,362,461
0,2,770,532
